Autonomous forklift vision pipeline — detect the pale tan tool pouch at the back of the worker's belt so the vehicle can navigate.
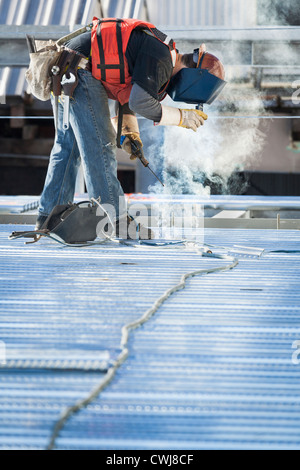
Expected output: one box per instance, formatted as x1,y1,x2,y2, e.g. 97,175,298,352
25,40,62,101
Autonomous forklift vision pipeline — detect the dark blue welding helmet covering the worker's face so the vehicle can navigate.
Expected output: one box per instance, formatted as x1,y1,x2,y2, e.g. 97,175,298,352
167,44,226,104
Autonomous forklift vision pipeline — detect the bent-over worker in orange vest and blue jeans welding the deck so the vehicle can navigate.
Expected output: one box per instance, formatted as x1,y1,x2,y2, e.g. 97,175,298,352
36,18,225,239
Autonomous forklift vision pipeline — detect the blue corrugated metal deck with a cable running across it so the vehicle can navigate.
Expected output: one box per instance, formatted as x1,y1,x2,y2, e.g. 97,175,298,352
0,226,300,450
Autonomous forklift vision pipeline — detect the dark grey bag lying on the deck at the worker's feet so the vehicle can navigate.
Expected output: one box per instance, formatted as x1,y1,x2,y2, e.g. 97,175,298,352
9,201,105,244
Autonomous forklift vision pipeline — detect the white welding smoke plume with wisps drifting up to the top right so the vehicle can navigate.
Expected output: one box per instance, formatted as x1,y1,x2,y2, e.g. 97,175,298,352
149,0,299,195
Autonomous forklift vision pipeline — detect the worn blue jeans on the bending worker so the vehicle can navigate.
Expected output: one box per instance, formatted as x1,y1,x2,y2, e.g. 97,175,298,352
39,70,125,218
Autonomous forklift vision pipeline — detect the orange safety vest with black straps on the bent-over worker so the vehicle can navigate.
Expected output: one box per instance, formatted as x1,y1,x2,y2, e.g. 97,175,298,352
92,18,176,105
